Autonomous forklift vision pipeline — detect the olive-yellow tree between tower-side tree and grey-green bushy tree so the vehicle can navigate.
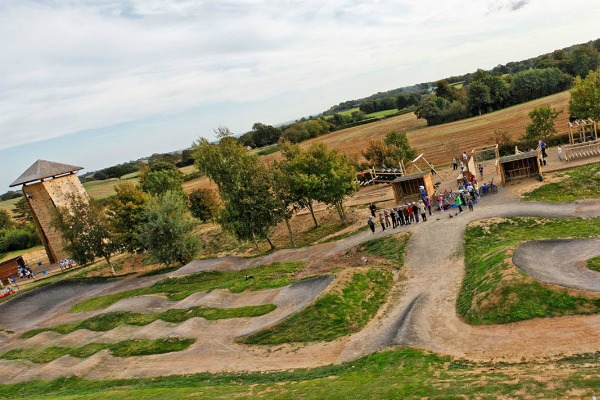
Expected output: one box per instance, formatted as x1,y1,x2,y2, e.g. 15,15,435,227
106,182,150,253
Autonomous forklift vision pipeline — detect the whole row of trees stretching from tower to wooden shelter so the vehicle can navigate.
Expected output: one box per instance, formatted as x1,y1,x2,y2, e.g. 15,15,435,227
54,131,357,274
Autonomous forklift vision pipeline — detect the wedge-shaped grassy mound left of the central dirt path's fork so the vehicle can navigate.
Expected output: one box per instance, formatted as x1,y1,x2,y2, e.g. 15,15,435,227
241,268,392,344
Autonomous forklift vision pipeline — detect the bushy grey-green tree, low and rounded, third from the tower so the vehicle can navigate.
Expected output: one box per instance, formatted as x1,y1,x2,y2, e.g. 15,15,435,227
139,191,201,266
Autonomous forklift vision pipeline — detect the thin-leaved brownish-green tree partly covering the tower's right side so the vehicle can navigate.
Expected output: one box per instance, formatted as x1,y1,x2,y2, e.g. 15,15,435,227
53,195,117,275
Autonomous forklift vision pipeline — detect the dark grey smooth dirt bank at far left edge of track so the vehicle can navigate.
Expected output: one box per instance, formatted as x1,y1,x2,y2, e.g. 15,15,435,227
0,279,116,330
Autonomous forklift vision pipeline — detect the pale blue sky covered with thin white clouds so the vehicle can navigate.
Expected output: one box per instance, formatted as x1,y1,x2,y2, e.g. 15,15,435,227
0,0,600,192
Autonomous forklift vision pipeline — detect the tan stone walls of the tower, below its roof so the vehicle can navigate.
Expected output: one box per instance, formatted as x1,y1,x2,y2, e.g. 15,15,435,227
23,174,88,263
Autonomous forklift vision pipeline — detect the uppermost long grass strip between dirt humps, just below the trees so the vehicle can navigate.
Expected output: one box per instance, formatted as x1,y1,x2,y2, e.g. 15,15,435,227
71,262,303,312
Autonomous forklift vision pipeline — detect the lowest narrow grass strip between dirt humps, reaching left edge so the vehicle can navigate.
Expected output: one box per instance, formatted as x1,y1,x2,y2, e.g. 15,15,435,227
0,337,195,364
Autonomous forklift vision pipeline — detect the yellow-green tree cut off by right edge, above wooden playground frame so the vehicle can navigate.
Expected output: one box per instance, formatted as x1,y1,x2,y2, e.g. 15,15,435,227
569,68,600,121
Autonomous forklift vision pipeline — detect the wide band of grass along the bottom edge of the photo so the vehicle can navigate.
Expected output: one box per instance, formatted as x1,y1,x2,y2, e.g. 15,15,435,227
5,348,600,400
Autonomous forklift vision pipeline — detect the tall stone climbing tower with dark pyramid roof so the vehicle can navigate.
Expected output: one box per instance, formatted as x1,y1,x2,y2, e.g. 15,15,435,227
10,160,88,263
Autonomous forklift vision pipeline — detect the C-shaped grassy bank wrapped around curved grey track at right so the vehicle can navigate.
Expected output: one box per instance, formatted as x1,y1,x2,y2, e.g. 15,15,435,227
456,217,600,325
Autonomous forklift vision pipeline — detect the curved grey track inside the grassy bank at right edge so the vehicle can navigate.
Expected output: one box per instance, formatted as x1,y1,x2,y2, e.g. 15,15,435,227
513,239,600,292
